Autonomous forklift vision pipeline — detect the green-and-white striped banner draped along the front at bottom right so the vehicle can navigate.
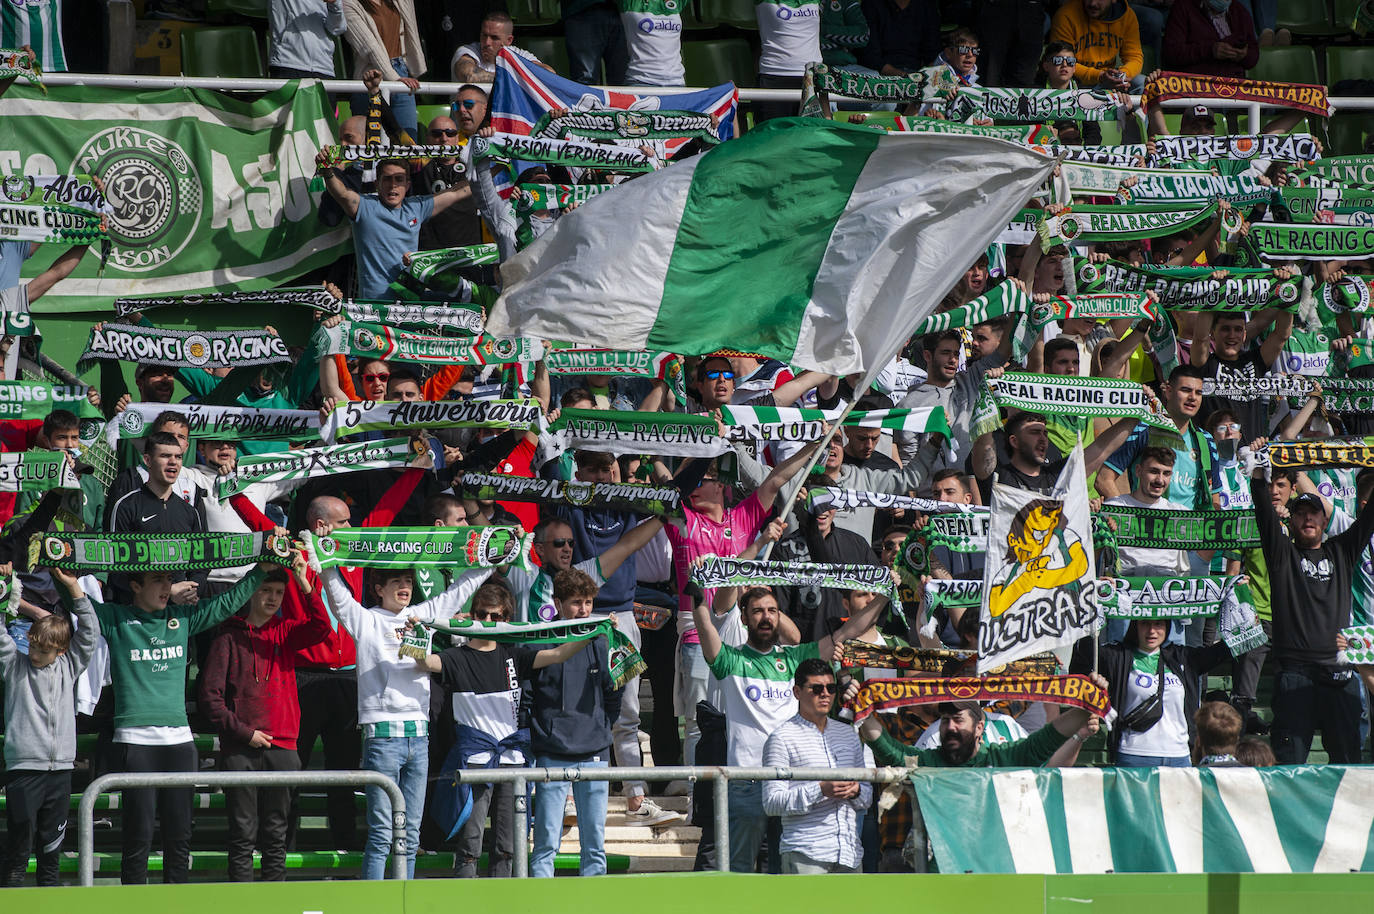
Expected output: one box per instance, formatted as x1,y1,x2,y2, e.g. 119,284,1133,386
911,766,1374,873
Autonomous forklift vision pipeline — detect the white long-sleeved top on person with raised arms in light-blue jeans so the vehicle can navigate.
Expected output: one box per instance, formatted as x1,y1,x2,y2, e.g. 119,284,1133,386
320,568,493,738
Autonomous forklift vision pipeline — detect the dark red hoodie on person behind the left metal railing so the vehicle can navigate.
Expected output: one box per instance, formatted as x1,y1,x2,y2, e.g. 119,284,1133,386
201,580,330,752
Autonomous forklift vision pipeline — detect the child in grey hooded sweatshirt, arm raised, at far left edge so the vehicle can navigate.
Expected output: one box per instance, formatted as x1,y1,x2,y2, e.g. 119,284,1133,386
0,569,100,887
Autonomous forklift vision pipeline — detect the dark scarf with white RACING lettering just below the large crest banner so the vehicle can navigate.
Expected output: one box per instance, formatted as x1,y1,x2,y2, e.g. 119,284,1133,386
77,323,294,374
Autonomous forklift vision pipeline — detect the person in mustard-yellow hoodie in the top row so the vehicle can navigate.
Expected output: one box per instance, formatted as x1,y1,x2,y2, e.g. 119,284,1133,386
1050,0,1145,92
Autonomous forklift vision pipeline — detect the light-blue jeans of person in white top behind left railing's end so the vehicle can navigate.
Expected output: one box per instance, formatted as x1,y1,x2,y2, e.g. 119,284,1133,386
363,737,429,880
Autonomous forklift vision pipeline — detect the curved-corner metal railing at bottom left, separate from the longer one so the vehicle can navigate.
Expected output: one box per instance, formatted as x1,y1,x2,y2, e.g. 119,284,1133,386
77,771,407,885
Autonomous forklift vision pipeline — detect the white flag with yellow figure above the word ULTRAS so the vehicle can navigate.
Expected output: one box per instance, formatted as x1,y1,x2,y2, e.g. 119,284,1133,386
978,443,1099,675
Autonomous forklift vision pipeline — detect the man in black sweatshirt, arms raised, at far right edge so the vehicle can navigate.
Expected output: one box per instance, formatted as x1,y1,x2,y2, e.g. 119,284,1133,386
1250,438,1374,764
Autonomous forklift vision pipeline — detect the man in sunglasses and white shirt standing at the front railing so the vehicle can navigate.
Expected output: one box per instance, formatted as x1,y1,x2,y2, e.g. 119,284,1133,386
763,658,872,874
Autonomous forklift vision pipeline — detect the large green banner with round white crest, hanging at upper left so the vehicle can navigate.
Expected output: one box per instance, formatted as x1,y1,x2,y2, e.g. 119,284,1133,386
0,82,349,306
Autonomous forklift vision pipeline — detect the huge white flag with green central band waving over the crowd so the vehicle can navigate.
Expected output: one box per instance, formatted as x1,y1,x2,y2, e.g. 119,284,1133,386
486,118,1054,374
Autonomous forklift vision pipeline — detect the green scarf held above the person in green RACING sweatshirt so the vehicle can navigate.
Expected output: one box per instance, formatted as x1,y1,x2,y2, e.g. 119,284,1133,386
29,532,291,572
